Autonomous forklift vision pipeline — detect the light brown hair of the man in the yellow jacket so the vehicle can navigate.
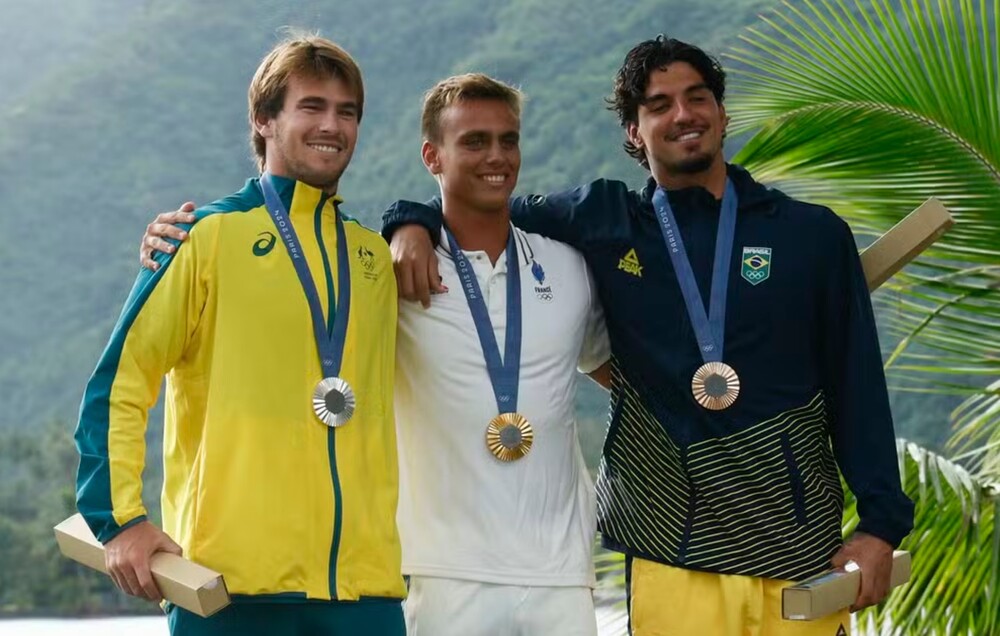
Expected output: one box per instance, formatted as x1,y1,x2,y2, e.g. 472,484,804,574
247,35,365,171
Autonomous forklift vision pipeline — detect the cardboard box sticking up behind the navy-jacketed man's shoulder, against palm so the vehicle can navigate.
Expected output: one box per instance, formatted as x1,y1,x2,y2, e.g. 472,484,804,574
861,198,955,291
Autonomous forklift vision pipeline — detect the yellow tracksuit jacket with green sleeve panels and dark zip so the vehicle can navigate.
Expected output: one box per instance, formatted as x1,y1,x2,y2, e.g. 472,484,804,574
76,177,405,600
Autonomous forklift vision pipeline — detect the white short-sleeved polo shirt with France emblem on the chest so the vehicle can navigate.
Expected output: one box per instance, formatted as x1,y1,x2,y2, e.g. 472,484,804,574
395,228,610,586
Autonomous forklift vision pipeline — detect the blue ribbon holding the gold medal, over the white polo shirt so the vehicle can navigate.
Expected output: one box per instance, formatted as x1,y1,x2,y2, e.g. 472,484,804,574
445,228,521,413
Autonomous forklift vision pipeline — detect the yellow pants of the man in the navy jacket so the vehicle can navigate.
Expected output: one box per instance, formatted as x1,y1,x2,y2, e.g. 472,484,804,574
629,558,851,636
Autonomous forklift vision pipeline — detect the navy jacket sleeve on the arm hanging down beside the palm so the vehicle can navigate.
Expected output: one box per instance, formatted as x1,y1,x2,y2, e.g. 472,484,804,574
821,217,913,547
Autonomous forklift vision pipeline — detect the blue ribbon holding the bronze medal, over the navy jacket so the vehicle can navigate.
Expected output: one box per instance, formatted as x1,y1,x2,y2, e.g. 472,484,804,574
653,179,737,363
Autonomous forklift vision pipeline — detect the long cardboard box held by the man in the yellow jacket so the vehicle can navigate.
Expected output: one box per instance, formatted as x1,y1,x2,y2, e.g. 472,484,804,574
55,514,229,617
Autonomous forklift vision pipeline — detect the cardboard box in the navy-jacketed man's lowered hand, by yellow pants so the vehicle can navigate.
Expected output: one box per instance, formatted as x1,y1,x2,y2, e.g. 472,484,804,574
781,550,910,621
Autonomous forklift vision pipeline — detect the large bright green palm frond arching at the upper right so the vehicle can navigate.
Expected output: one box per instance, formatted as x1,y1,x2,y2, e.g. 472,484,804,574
728,0,1000,390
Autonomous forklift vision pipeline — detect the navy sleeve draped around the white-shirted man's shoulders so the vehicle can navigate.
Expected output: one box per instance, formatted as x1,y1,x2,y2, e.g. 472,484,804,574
382,179,635,249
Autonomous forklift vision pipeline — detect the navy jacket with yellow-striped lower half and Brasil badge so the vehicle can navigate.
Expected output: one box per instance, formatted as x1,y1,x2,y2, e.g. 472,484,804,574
383,166,913,579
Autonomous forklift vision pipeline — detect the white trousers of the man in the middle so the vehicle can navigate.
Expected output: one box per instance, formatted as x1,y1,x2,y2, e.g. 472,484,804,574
403,576,597,636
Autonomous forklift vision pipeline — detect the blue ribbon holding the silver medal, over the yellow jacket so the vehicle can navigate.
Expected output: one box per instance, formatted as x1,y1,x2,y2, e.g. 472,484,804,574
260,172,351,378
